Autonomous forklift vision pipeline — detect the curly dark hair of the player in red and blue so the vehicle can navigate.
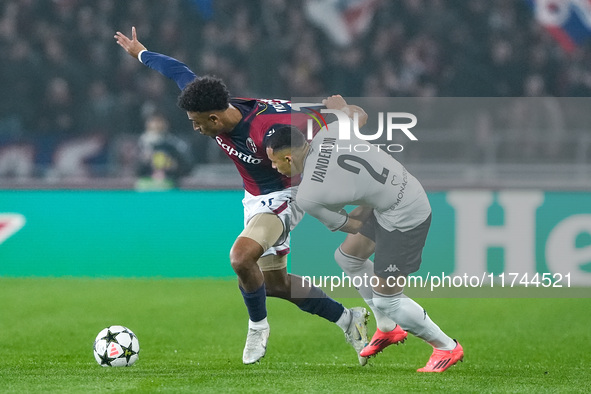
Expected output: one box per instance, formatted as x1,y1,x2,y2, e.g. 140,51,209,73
177,76,230,112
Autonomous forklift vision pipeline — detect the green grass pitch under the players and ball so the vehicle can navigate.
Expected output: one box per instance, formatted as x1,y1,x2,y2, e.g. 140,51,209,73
0,278,591,393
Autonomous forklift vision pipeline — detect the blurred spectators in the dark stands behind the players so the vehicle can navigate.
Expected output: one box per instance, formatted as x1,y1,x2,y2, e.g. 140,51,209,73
0,0,591,188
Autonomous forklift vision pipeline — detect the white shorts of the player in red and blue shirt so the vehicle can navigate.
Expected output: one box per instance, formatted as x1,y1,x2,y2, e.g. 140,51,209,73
242,186,304,256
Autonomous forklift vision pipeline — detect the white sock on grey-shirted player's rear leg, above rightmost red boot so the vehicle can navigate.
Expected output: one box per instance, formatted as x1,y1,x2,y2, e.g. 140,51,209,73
373,291,456,350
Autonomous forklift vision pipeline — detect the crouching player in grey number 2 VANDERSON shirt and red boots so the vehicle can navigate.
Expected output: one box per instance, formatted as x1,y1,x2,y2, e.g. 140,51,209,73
265,96,464,372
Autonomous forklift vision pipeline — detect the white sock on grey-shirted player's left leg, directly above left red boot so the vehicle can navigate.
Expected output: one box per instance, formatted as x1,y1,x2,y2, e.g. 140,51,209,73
334,247,396,332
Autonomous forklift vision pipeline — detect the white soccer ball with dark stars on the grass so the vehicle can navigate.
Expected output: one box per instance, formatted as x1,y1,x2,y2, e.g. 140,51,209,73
93,326,140,367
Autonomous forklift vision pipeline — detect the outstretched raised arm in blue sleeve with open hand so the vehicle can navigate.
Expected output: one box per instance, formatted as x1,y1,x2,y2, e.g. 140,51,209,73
115,27,197,90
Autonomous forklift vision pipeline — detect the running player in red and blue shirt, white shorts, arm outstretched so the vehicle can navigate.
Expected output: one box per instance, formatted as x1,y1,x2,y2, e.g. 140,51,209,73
115,27,368,365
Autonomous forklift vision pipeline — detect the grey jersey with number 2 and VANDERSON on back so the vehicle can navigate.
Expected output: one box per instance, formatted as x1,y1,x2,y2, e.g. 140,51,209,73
296,122,431,231
